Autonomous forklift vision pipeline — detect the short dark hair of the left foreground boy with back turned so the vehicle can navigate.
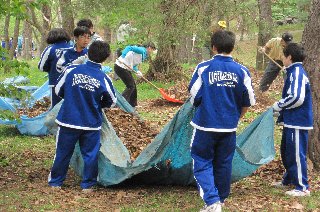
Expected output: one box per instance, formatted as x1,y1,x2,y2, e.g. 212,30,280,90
88,41,111,63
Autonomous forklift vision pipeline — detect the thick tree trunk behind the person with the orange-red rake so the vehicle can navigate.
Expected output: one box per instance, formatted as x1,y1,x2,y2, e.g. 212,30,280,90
146,0,197,80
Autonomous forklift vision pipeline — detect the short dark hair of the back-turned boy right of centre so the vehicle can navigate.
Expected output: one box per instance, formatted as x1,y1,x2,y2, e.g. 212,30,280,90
211,30,236,54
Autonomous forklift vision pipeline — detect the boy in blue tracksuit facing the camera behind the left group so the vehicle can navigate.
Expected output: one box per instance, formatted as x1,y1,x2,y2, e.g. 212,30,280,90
57,26,91,73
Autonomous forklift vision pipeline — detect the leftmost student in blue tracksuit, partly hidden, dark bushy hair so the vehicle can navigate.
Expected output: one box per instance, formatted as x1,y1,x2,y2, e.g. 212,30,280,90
38,28,70,108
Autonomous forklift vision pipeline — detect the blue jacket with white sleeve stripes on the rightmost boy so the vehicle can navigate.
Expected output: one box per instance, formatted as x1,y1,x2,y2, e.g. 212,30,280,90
275,62,313,130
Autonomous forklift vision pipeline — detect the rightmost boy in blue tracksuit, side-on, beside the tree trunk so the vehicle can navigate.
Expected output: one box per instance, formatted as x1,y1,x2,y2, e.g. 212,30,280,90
273,43,313,196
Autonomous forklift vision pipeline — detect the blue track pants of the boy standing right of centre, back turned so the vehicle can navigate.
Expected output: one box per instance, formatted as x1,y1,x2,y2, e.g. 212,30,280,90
191,129,236,205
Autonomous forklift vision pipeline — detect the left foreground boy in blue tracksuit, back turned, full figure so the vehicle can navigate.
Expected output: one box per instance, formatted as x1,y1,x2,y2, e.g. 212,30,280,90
48,41,117,192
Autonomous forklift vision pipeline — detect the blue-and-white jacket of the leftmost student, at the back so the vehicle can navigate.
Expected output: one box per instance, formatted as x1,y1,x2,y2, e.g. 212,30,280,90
38,41,70,86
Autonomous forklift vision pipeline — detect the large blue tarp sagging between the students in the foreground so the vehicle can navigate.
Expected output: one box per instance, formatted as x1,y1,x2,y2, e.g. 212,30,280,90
46,94,275,186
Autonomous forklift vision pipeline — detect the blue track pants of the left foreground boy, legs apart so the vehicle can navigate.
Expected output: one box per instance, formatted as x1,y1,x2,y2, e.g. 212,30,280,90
48,126,100,188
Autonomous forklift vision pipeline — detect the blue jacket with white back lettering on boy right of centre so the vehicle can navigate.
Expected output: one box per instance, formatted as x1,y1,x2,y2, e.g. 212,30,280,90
189,54,255,132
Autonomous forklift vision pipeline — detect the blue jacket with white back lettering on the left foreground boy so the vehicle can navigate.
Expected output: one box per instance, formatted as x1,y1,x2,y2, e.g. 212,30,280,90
55,61,117,130
